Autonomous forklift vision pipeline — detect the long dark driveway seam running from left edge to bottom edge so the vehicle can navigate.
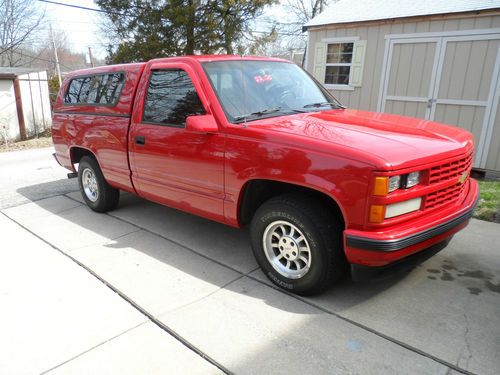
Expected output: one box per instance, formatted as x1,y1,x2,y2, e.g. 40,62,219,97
0,211,232,374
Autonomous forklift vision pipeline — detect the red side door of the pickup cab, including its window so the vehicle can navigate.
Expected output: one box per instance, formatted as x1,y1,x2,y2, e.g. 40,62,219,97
129,63,224,221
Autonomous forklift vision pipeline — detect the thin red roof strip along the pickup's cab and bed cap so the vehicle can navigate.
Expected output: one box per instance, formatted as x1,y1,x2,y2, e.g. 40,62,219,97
64,55,290,76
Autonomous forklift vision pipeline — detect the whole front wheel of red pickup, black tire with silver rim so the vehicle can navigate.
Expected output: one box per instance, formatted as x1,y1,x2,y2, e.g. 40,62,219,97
250,195,347,295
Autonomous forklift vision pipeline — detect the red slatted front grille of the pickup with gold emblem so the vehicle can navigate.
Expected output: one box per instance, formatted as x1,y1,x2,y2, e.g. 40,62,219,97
424,153,472,209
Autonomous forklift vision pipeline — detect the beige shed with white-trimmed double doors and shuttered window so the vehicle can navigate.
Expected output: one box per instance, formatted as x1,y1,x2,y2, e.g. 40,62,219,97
306,0,500,172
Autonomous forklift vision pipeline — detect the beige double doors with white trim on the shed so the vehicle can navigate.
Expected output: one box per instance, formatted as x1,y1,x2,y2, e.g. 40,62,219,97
379,34,500,170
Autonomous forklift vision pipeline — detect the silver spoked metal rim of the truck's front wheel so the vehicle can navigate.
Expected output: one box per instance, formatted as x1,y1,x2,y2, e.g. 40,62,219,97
262,220,311,279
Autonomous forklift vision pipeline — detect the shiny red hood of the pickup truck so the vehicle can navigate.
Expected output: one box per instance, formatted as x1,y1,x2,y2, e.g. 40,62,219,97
249,109,473,169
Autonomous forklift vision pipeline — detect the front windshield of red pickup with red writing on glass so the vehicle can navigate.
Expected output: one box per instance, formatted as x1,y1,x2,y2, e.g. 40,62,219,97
203,60,343,123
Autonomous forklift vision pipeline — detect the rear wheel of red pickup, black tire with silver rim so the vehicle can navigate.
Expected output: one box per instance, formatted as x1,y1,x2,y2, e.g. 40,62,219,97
78,156,120,212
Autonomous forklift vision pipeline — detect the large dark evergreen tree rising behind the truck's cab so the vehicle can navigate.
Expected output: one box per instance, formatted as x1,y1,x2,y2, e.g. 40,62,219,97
96,0,277,63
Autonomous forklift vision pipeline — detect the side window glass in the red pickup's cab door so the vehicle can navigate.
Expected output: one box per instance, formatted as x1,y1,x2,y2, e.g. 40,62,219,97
142,69,205,127
